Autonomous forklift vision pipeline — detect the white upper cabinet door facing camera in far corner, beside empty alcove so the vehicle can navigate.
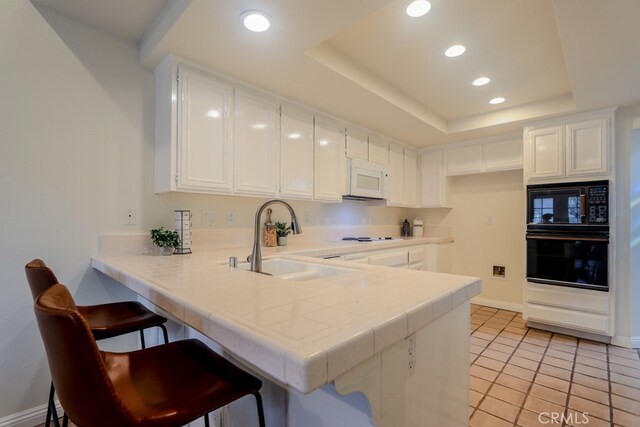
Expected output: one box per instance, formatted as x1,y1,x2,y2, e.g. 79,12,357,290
420,150,448,208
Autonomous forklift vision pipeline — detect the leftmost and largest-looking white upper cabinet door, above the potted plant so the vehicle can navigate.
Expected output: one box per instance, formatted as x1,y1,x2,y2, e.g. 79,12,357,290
176,68,232,193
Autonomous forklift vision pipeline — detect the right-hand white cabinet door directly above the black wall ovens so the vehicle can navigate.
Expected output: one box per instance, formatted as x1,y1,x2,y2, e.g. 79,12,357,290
567,118,609,176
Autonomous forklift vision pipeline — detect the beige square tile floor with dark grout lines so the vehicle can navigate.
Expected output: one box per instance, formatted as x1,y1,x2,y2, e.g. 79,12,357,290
469,305,640,427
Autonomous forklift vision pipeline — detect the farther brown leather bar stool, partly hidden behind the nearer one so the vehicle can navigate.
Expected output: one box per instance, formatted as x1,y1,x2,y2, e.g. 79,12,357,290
24,259,169,427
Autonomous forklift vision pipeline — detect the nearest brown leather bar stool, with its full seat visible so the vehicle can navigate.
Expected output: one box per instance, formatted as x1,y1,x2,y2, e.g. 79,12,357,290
34,284,264,427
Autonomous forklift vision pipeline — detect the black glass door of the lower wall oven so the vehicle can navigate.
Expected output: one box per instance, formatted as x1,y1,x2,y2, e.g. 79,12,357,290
527,232,609,291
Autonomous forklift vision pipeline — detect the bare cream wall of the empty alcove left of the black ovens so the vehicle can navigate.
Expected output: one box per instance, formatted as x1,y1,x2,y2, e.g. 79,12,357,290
420,170,525,309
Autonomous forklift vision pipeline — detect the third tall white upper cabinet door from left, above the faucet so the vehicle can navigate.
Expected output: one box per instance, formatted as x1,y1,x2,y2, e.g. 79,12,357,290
280,106,313,199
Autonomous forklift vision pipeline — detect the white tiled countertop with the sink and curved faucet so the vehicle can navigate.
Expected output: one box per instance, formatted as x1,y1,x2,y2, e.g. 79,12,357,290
92,239,481,393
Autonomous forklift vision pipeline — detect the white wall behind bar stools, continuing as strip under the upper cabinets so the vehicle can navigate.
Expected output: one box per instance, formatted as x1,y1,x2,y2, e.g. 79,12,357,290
0,0,406,424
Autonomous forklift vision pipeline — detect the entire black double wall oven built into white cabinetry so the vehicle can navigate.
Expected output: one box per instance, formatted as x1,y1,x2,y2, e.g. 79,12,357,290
526,181,609,291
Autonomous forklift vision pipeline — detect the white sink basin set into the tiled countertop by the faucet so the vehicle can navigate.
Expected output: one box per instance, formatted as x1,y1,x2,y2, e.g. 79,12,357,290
238,258,356,281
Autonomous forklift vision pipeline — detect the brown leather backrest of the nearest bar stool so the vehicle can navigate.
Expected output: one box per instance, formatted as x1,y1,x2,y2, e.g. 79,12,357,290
34,284,136,427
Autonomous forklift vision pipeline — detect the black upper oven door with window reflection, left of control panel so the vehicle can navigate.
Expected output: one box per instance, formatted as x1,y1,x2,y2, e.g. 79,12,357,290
527,184,585,225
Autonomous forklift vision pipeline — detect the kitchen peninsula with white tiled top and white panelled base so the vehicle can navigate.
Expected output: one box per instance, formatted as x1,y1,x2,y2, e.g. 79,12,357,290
92,241,481,427
